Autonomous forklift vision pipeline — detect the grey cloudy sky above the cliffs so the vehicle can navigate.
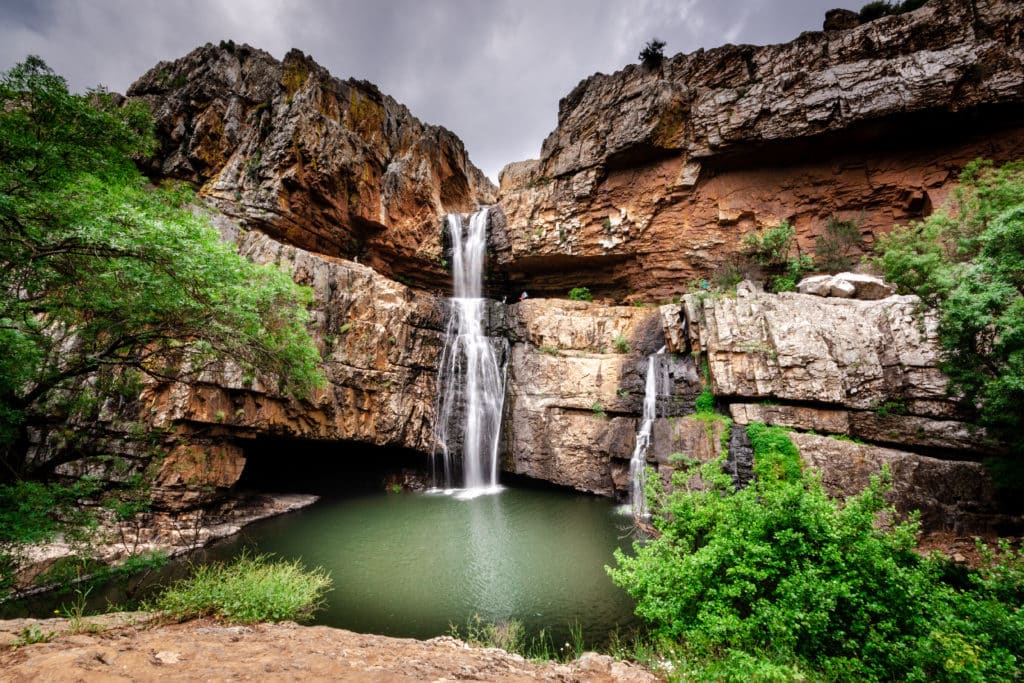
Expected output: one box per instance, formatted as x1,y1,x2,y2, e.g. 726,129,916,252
0,0,863,180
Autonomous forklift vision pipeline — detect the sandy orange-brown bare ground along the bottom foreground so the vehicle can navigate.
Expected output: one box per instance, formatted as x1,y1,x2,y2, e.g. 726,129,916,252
0,612,658,683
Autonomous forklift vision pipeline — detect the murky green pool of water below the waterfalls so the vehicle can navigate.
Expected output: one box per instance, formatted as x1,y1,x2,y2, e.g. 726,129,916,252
209,488,634,642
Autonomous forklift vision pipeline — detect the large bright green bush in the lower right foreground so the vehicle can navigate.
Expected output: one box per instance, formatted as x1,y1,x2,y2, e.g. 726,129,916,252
609,425,1024,681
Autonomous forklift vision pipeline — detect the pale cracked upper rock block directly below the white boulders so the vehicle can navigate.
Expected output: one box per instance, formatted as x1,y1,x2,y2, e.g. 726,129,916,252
685,293,997,453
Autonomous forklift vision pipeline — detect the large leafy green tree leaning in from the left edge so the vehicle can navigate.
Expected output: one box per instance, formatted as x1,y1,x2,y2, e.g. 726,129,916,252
0,57,323,476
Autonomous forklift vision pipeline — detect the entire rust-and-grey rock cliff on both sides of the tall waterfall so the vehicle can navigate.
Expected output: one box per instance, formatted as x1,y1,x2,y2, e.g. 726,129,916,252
33,0,1024,540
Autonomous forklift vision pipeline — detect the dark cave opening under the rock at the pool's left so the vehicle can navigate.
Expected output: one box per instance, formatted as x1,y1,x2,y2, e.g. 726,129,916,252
234,437,430,497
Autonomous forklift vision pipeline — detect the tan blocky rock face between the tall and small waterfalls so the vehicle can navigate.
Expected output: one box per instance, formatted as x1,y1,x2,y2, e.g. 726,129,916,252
505,299,698,498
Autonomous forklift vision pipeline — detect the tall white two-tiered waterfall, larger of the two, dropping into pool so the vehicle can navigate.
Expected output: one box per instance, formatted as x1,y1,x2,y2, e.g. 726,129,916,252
433,209,505,496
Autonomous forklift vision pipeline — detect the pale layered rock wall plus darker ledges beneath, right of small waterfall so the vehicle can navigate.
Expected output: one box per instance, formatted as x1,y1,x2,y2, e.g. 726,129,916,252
660,288,1022,532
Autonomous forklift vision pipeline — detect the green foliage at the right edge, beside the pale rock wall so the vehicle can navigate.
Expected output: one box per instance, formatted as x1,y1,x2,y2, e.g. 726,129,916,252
873,161,1024,452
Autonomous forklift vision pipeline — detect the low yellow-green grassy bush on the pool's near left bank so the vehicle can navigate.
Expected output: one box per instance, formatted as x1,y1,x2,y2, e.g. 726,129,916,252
153,553,332,624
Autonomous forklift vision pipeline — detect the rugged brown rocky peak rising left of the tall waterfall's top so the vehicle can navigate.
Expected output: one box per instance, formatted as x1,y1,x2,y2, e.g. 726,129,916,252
128,42,495,287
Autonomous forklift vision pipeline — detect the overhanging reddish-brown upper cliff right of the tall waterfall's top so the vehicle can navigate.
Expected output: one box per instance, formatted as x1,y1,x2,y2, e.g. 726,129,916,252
500,0,1024,300
